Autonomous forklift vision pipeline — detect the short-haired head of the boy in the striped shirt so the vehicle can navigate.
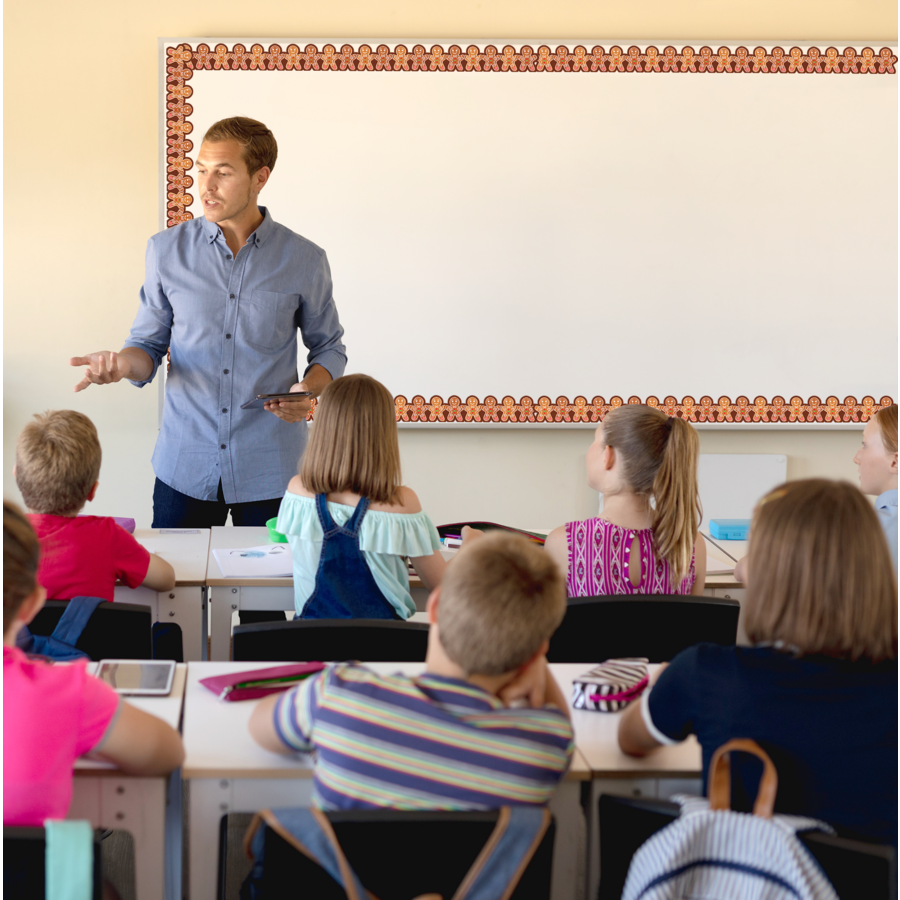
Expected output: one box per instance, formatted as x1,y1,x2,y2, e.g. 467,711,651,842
437,532,566,676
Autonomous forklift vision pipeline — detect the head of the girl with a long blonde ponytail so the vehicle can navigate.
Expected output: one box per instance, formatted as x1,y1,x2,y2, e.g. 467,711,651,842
587,405,702,579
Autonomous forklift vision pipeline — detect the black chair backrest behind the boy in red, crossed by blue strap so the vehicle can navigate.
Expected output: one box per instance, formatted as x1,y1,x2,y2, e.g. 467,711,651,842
28,600,153,660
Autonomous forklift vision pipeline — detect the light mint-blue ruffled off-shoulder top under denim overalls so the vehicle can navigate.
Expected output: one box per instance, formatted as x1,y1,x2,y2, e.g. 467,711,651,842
275,491,441,619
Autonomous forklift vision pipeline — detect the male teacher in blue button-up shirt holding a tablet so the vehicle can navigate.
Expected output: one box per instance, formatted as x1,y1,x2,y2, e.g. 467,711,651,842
69,117,347,528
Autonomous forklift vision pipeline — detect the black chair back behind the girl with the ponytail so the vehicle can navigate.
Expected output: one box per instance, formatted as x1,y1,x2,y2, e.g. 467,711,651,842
547,594,741,663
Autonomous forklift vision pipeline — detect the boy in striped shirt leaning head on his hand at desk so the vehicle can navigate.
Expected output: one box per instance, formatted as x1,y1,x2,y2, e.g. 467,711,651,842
250,533,573,810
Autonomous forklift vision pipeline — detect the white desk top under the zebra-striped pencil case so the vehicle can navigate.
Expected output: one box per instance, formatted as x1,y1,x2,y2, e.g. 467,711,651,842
550,663,702,778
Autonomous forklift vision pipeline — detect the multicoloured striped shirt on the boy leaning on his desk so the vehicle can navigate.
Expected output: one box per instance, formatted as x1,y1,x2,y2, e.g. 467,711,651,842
275,665,574,810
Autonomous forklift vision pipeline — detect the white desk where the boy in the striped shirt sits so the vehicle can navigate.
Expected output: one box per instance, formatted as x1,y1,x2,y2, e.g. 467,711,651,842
182,662,590,900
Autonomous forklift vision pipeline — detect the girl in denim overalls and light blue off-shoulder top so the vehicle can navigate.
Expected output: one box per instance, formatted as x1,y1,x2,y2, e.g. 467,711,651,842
277,375,445,619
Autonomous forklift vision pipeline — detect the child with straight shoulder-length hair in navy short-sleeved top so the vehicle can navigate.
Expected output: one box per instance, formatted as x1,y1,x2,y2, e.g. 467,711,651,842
619,479,897,847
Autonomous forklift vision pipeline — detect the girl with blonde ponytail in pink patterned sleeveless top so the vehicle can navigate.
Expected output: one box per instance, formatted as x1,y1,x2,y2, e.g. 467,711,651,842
545,406,706,597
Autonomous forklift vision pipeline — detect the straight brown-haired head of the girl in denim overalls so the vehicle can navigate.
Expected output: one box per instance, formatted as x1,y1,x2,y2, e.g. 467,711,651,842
300,375,400,503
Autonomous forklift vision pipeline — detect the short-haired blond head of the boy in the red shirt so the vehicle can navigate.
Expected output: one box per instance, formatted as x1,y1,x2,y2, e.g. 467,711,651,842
16,409,100,516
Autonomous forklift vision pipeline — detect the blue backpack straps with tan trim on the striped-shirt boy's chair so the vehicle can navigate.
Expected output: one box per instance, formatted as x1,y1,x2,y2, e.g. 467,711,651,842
241,806,551,900
